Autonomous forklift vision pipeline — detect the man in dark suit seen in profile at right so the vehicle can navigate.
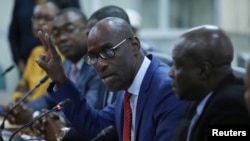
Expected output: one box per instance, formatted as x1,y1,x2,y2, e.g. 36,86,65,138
169,25,250,141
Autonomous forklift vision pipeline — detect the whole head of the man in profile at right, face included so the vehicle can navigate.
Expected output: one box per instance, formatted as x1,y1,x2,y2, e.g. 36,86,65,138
169,25,233,101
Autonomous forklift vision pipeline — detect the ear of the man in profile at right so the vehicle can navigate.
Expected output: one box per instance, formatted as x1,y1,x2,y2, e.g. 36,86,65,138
199,61,212,80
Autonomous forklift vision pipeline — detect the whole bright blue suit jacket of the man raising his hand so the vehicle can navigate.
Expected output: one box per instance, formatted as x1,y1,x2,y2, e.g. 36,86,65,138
48,55,186,141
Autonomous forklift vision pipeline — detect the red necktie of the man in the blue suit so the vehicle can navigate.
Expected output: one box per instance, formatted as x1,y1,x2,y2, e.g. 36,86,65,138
123,92,132,141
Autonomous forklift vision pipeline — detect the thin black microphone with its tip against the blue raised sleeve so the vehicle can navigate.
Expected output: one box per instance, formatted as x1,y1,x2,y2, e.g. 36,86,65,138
9,99,70,141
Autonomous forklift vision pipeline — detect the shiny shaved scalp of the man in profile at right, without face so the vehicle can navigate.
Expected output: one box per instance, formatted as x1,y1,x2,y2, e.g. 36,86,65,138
177,25,234,66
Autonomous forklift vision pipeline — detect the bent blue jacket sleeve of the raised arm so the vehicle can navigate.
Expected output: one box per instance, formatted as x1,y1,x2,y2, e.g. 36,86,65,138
48,80,115,140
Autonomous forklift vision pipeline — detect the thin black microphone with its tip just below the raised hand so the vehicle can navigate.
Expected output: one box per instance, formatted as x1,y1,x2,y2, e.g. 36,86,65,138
0,75,49,131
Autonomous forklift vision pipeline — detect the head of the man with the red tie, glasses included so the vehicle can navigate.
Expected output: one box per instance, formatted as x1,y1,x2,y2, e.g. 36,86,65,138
86,17,144,91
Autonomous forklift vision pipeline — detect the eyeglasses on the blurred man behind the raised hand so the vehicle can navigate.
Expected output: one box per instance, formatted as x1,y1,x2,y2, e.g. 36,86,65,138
52,25,86,39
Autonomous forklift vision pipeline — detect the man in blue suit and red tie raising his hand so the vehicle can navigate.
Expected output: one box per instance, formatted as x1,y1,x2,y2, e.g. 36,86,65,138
37,17,186,141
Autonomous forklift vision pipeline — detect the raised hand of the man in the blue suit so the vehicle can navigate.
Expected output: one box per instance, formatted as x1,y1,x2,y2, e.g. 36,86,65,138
36,26,67,86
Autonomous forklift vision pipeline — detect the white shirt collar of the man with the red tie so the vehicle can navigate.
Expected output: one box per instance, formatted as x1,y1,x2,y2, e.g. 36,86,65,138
128,56,151,95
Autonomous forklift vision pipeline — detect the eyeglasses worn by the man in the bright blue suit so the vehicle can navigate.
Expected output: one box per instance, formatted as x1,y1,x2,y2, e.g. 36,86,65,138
84,37,133,65
